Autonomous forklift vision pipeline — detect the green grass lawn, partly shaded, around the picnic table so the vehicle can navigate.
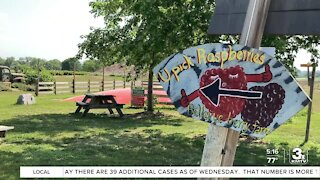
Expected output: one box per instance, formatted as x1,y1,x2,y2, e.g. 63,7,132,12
0,80,320,180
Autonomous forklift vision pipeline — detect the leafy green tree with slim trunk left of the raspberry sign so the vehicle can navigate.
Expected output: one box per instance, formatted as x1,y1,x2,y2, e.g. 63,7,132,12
82,0,217,111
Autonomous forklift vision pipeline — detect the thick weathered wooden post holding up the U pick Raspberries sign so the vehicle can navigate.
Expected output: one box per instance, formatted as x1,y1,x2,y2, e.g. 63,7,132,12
201,0,270,173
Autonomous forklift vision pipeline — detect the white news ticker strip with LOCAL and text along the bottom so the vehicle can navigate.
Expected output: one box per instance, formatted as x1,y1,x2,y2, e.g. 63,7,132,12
20,166,320,178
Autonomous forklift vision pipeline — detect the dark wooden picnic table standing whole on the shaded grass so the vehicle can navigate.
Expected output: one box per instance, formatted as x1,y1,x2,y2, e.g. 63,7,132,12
75,94,124,117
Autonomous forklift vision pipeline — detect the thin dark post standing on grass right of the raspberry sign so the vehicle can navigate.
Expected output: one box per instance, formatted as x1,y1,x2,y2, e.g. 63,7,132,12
304,63,316,143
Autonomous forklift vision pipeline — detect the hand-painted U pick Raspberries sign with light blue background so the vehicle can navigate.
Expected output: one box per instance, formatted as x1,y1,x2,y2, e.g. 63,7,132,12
153,43,310,138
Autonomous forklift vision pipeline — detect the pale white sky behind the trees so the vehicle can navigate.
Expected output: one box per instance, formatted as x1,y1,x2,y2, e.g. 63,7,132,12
0,0,310,67
